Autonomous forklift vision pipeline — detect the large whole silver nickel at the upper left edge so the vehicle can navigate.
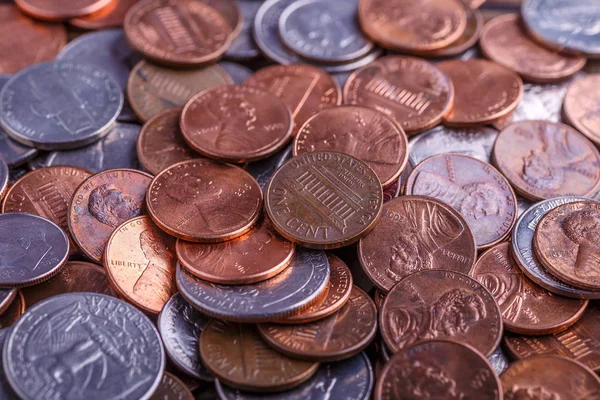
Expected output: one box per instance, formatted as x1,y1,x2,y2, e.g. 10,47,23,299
0,61,123,150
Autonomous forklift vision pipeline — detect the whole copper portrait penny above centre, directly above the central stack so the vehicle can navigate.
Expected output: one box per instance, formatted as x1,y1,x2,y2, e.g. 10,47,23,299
181,85,294,163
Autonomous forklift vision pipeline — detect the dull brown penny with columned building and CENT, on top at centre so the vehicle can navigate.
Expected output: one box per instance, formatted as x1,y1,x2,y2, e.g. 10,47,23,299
265,152,383,249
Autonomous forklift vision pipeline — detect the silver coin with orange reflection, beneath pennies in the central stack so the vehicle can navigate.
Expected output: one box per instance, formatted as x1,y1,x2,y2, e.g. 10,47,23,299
176,248,329,322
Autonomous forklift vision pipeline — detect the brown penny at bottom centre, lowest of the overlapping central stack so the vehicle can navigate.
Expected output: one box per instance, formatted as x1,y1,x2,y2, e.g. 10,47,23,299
200,319,319,392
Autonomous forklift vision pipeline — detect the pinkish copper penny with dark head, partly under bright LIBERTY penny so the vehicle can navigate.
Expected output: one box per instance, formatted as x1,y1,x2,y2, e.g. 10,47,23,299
68,168,152,262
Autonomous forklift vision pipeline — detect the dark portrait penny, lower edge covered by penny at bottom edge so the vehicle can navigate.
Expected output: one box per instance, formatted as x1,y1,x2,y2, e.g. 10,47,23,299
379,270,502,356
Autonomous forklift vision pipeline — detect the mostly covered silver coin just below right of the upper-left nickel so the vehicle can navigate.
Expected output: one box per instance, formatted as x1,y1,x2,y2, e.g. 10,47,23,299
45,123,141,172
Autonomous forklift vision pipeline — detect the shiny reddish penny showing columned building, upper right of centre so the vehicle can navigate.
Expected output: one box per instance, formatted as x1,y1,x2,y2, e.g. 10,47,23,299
344,56,454,135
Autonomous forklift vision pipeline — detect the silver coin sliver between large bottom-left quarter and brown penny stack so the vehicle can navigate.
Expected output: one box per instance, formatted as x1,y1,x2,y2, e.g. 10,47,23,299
156,293,214,381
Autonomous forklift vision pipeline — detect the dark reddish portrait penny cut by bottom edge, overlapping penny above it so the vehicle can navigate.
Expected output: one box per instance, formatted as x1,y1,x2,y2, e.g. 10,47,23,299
373,340,503,400
